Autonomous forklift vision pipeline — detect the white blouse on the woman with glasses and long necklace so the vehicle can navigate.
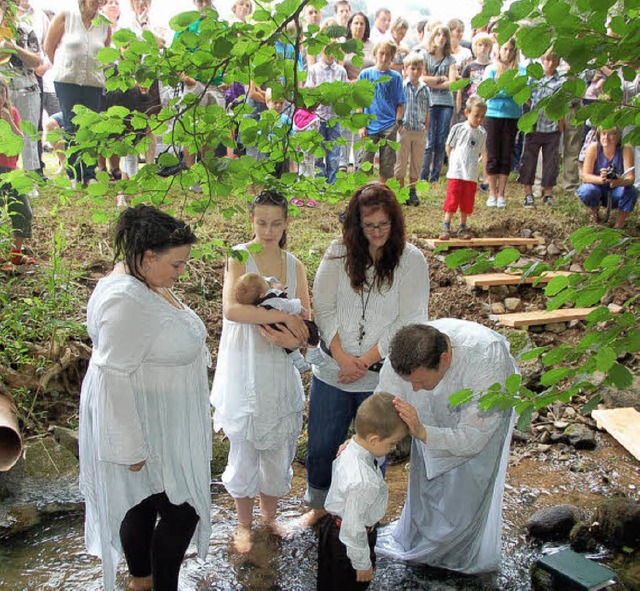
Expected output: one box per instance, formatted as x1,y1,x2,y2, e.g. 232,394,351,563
313,240,429,392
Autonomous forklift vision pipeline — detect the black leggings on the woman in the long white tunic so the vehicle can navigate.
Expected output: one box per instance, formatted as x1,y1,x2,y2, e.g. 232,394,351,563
120,493,199,591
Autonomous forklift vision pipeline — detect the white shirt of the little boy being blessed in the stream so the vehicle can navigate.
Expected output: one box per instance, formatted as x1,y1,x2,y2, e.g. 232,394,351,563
324,438,389,570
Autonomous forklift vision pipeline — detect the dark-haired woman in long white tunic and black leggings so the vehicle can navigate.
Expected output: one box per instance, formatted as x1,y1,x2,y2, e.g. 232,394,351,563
80,205,211,591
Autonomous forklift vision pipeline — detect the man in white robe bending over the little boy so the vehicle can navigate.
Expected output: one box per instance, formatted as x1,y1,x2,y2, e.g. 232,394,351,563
376,319,519,573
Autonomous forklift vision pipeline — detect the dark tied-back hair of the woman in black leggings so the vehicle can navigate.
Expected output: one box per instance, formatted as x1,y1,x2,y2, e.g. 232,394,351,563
113,205,198,284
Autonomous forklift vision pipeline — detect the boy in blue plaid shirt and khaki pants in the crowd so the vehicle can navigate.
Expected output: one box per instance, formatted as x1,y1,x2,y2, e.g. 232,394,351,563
393,52,431,207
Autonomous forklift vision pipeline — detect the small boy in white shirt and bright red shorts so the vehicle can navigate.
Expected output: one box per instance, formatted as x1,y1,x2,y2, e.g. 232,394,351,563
440,95,487,240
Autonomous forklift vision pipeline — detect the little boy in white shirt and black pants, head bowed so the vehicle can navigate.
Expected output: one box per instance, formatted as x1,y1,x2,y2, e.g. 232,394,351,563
317,392,409,591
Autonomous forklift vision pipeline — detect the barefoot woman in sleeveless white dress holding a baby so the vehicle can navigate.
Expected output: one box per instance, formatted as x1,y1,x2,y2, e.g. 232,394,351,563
211,190,310,553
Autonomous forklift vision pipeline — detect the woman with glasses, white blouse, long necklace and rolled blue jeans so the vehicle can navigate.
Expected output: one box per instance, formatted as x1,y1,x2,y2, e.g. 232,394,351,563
303,183,429,525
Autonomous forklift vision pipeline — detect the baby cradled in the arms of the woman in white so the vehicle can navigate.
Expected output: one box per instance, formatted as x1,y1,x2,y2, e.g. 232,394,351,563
235,273,323,372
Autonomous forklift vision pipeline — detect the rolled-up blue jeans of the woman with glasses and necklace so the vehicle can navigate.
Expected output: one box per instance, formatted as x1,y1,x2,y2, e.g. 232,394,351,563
306,376,372,509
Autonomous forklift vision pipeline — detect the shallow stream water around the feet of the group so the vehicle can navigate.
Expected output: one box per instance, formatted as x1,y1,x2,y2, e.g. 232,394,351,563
0,466,535,591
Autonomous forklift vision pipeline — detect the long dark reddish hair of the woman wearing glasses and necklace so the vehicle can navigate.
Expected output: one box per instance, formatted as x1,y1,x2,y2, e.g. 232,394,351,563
342,183,406,292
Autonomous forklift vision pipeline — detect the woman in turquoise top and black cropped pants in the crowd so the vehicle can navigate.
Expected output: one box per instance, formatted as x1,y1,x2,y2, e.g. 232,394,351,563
484,38,525,207
